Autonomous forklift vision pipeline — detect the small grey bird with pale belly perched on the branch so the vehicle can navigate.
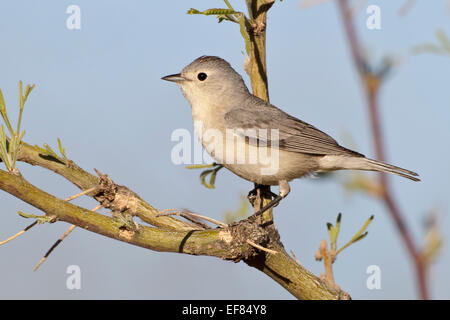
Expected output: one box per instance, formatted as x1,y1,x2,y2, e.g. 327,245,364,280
162,56,420,214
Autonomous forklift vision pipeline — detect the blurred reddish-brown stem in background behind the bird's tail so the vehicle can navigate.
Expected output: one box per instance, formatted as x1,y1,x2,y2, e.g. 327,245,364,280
338,0,428,299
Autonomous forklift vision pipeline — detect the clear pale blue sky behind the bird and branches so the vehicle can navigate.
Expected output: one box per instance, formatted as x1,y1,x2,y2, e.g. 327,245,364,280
0,0,450,299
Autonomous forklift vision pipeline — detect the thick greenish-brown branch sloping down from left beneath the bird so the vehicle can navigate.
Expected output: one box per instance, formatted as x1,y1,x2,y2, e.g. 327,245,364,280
0,170,349,299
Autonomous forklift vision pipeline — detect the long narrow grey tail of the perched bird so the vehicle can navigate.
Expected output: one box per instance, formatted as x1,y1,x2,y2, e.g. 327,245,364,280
320,155,420,181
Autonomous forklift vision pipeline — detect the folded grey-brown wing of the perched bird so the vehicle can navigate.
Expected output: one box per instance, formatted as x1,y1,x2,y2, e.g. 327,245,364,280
225,99,363,157
